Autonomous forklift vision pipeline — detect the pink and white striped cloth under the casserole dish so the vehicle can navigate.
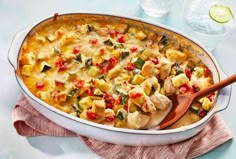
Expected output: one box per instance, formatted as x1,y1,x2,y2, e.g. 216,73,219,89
12,96,233,159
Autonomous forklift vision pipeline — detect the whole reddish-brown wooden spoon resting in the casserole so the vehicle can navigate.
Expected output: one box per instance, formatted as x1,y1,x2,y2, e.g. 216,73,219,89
159,74,236,129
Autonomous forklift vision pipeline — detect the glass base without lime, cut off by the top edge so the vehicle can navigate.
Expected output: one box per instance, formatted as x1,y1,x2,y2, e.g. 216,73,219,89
140,0,174,17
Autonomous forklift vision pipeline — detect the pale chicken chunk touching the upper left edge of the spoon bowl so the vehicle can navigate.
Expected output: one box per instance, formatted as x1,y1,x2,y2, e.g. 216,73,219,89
150,91,172,111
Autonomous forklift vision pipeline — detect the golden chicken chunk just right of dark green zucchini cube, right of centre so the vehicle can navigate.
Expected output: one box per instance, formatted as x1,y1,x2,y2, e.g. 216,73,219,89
141,61,159,77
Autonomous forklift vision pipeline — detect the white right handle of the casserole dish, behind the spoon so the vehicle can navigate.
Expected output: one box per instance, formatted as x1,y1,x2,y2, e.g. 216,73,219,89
214,69,232,113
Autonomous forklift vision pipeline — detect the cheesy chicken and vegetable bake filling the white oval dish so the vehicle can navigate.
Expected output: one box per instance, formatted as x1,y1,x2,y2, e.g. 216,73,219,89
19,18,214,129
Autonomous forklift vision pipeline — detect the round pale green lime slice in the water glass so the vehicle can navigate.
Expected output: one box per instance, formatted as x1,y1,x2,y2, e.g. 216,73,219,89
209,4,234,23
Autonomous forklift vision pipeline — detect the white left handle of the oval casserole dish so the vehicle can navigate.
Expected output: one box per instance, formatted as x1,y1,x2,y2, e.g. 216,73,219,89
8,29,29,70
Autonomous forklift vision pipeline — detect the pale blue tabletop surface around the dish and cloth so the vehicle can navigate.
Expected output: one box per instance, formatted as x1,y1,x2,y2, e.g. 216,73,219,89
0,0,236,159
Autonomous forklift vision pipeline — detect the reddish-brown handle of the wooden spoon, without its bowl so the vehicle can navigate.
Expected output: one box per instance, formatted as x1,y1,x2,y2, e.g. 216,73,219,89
193,74,236,99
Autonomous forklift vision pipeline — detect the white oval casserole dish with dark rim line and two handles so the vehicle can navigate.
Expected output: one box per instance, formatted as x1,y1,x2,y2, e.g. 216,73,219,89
8,13,231,146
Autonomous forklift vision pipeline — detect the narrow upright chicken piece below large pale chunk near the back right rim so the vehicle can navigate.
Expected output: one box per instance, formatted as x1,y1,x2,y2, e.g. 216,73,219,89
159,57,171,79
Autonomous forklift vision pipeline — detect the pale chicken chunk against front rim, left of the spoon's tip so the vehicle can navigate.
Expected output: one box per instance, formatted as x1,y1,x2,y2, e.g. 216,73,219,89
127,111,150,129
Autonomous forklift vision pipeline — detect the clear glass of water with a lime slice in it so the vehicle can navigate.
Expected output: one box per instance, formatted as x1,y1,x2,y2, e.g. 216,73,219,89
184,0,236,50
